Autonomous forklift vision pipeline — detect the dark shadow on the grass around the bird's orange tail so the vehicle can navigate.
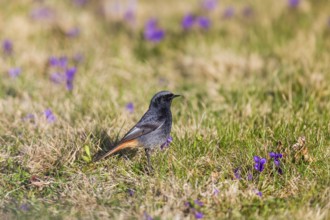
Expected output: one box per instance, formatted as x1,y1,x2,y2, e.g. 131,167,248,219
92,129,138,162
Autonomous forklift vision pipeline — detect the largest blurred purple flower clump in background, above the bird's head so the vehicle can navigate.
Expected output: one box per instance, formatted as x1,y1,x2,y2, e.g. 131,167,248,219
144,19,165,43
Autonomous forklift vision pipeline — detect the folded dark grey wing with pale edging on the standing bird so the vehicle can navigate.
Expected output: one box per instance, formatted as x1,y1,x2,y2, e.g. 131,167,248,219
120,120,165,143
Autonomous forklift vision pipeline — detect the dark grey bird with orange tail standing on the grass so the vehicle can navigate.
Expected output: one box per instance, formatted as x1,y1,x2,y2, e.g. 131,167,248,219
93,91,180,169
